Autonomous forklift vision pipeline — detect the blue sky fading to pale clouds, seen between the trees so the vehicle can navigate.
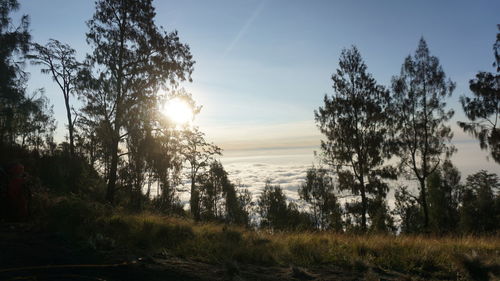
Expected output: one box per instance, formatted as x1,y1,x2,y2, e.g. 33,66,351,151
14,0,500,196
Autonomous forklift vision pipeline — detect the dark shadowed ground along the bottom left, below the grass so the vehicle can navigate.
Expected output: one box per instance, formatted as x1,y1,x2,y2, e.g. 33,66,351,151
0,223,430,281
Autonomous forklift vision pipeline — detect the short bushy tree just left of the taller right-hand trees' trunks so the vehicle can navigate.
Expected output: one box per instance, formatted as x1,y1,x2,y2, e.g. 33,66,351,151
298,167,342,231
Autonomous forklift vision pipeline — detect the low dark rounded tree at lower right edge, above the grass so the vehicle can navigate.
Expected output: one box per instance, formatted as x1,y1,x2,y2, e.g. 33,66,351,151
460,170,500,234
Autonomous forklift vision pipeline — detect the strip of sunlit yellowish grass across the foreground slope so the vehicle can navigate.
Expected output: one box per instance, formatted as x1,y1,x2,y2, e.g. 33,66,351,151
37,196,500,279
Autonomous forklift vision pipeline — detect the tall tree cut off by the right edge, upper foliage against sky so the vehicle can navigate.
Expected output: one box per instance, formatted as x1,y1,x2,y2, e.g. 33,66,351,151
457,25,500,164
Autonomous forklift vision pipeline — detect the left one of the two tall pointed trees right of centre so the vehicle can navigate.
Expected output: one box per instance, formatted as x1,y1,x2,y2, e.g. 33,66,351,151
315,46,395,231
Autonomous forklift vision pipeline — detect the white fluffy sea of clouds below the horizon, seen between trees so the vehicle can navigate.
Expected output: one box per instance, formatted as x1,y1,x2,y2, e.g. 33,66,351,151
171,133,498,212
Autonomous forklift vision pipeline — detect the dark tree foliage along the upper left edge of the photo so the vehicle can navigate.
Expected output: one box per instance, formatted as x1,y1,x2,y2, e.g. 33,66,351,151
0,0,55,150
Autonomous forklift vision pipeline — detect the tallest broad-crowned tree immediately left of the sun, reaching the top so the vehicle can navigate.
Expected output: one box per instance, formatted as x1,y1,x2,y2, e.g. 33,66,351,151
84,0,194,202
